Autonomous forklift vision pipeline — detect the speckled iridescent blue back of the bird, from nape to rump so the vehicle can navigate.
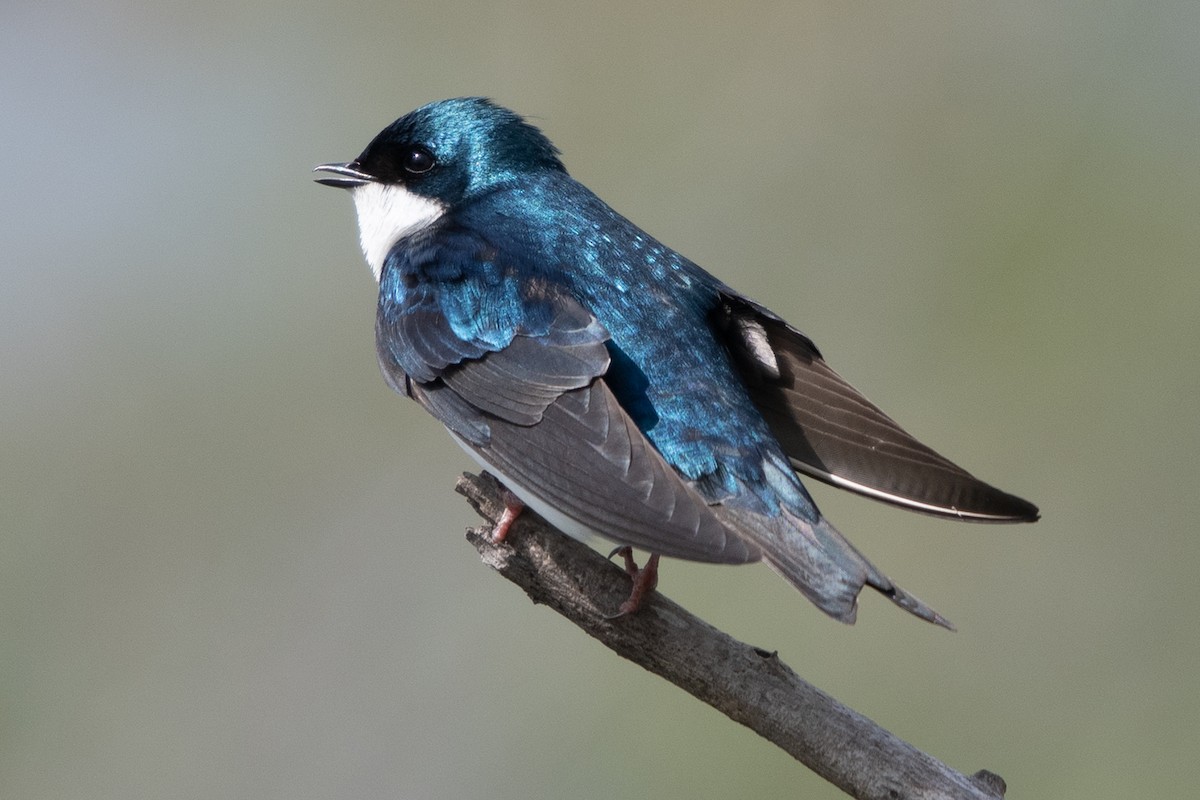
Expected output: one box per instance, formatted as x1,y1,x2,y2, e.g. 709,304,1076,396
455,172,820,521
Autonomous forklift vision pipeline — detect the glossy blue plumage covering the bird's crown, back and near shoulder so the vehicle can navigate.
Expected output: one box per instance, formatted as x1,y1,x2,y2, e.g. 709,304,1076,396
362,100,818,521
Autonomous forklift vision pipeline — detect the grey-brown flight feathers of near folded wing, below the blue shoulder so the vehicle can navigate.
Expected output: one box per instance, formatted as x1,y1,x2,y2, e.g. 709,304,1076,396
393,284,761,564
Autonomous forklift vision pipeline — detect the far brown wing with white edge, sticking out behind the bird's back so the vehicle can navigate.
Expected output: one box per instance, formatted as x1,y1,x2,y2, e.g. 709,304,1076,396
719,294,1038,522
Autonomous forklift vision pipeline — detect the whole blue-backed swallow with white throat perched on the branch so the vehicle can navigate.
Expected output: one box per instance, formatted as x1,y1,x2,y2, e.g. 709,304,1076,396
314,97,1039,630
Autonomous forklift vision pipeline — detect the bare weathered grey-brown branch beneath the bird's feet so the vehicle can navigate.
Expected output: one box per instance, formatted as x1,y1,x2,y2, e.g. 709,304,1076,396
457,473,1006,800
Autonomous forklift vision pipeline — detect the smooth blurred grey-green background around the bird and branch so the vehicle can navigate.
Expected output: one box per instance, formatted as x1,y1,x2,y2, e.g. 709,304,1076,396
0,0,1200,800
